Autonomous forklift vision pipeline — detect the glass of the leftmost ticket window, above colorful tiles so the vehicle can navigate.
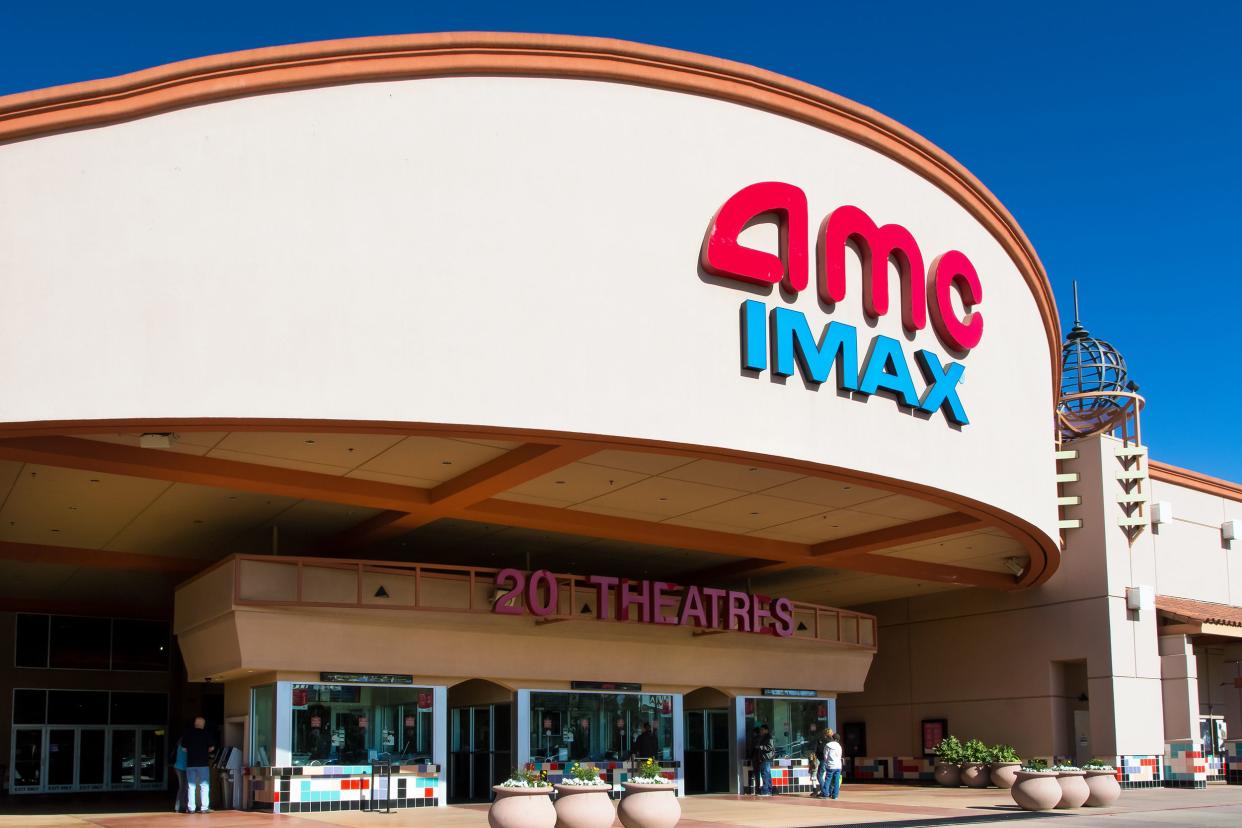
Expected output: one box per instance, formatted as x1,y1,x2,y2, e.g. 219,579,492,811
292,684,433,765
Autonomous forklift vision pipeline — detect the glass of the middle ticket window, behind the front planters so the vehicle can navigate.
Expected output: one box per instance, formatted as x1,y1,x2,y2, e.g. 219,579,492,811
530,693,673,762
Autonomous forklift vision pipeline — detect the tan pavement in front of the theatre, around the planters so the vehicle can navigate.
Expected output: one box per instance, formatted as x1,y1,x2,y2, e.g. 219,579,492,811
0,785,1242,828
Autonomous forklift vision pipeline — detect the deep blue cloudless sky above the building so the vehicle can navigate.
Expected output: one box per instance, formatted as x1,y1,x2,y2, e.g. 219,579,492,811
0,0,1242,480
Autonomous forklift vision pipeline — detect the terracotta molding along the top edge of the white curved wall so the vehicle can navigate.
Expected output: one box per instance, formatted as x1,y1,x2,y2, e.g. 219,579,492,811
0,32,1061,397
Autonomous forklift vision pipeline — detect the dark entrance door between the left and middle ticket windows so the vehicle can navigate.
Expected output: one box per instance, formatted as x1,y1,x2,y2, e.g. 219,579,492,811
448,704,513,802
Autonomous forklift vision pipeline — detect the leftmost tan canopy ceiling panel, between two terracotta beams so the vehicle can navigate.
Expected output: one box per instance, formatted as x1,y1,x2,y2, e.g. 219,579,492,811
0,463,170,549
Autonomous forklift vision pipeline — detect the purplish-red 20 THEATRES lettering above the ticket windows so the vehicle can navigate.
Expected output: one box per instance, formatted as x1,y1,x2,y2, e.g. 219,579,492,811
492,569,794,638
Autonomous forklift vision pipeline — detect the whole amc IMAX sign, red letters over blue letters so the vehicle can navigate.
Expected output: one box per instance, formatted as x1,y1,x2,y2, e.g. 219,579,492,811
702,181,984,426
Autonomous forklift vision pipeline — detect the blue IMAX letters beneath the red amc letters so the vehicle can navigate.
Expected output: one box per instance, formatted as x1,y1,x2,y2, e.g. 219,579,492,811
741,299,970,426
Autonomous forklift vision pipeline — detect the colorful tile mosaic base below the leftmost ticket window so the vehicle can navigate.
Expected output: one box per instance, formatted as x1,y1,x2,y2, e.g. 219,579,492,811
250,765,440,813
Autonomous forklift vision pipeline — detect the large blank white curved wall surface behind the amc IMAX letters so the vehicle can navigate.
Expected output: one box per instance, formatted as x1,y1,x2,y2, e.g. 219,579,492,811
0,77,1056,538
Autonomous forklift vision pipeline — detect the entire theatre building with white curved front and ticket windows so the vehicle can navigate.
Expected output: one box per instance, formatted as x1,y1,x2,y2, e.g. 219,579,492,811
0,34,1242,812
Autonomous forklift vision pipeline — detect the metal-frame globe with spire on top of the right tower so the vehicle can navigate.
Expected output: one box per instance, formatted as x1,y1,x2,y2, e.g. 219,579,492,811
1057,283,1143,441
